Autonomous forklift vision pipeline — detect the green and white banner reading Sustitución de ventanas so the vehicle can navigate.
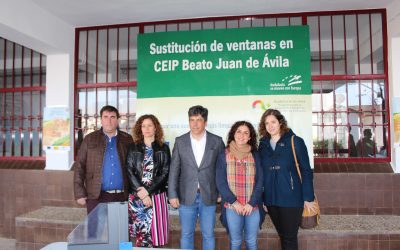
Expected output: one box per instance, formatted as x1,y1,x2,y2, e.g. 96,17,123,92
137,26,312,166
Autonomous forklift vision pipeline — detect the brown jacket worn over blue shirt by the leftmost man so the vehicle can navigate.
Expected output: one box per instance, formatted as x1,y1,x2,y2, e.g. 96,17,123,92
72,129,133,199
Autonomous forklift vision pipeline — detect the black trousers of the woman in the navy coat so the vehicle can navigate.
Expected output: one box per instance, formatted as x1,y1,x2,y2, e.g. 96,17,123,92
267,206,303,250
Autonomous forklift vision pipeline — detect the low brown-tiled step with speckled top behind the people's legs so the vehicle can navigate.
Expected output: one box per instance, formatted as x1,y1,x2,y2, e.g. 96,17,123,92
14,207,400,250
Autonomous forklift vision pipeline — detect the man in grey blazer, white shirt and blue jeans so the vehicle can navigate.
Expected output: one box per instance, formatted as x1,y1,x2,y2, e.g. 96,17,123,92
168,105,224,250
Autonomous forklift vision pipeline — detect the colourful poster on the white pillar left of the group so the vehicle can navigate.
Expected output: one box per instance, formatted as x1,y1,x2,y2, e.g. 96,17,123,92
43,107,71,151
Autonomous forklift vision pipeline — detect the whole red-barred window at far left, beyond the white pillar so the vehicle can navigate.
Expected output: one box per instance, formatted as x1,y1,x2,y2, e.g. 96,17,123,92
0,37,46,158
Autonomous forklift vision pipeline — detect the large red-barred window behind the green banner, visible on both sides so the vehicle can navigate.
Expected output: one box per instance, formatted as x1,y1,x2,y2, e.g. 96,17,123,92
75,10,390,162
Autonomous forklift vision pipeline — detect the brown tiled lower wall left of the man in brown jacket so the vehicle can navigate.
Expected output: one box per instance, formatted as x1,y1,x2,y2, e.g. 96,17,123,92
0,169,75,238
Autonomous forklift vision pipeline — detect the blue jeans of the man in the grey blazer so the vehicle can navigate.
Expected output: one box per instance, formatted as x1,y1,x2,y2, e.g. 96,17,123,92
179,193,216,250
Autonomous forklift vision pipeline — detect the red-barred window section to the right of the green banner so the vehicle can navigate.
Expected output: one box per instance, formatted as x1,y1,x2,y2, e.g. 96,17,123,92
307,12,389,160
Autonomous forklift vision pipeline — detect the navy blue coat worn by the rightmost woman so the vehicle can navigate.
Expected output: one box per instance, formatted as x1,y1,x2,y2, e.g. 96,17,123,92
258,130,314,207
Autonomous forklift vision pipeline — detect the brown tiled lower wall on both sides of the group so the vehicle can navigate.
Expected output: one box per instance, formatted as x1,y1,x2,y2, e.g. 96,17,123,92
0,169,400,238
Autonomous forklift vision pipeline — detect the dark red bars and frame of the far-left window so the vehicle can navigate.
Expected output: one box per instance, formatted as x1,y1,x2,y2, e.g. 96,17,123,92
0,37,46,161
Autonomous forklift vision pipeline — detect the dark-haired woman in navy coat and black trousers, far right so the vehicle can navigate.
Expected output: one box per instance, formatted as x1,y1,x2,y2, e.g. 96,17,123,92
258,109,315,250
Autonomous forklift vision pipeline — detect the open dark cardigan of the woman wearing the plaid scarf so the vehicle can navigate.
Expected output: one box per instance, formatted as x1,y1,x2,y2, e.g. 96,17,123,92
216,151,265,230
